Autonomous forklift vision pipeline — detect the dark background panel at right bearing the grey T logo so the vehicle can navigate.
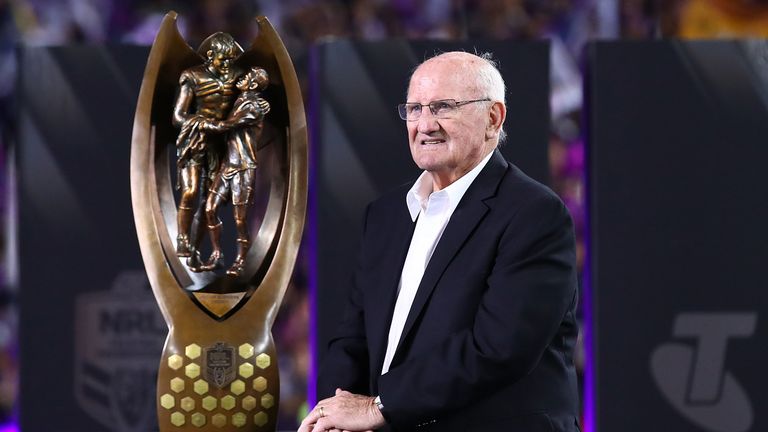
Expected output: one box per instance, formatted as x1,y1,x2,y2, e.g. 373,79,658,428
587,41,768,432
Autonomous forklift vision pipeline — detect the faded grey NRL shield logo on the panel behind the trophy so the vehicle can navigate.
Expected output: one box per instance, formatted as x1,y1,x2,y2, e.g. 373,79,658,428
74,271,168,432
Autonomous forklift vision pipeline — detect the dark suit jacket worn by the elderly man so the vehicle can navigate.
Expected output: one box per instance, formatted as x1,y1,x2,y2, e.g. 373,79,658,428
319,151,579,432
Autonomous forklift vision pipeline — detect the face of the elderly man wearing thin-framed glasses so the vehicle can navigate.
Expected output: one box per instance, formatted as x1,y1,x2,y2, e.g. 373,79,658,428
406,59,492,188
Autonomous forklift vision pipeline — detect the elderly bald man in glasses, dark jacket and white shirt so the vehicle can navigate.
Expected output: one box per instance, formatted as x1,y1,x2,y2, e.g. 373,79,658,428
299,52,579,432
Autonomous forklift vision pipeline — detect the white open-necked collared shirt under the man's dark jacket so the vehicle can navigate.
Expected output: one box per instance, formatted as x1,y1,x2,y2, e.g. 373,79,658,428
381,151,493,375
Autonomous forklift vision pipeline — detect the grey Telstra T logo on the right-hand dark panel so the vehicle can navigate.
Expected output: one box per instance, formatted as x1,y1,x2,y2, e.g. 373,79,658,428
651,312,757,432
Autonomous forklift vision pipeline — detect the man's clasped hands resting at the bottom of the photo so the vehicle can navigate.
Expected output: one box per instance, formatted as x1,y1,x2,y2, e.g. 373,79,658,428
299,389,386,432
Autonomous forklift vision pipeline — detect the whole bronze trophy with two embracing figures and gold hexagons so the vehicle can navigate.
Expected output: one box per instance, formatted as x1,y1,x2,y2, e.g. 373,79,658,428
131,12,307,432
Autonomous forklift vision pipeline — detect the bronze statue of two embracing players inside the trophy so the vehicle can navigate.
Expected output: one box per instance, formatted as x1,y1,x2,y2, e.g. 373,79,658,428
173,33,270,276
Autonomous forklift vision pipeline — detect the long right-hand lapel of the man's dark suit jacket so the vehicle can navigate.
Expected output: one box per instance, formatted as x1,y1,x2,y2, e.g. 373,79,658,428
390,150,509,365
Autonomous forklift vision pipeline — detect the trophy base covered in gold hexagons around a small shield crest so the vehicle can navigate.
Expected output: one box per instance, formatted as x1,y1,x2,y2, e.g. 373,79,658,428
157,333,280,432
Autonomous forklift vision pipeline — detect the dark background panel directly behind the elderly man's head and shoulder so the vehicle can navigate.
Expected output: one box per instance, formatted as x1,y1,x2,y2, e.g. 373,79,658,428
310,40,549,384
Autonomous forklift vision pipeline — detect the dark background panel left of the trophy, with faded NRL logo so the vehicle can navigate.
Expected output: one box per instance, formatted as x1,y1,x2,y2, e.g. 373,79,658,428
16,46,160,432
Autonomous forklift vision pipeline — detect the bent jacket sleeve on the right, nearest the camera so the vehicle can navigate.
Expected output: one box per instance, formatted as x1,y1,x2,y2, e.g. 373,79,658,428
379,195,576,428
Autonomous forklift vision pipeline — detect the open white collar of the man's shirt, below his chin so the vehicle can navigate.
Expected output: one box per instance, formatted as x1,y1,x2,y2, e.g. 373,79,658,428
405,150,495,221
